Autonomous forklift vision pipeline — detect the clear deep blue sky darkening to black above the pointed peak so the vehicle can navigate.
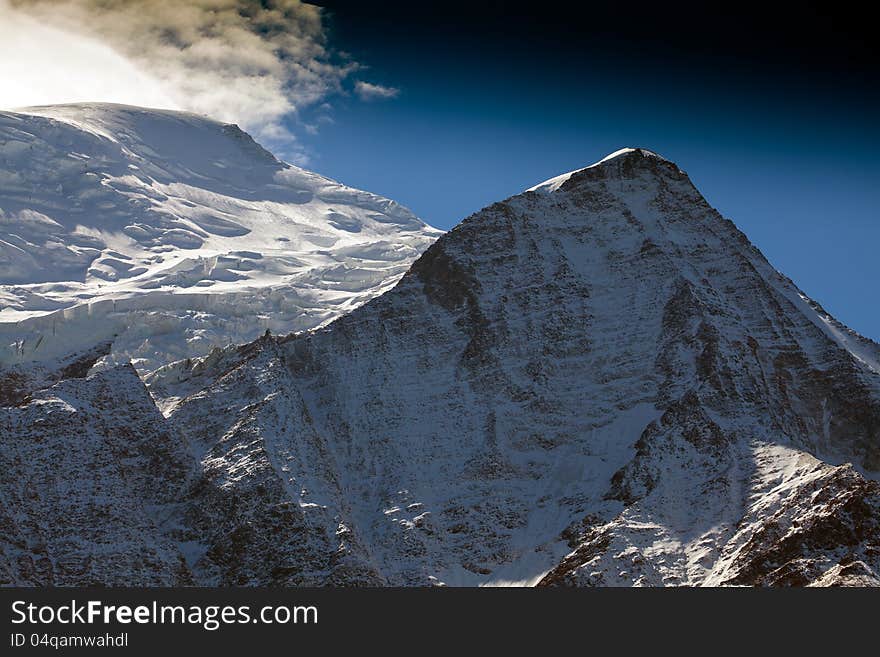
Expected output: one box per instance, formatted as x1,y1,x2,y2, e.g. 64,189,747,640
304,2,880,340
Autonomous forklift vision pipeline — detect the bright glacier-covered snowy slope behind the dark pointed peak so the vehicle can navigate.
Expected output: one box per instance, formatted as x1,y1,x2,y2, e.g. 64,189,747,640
0,104,441,371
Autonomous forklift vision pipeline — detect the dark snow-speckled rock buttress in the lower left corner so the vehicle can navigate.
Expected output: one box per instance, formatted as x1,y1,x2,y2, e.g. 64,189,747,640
0,366,195,586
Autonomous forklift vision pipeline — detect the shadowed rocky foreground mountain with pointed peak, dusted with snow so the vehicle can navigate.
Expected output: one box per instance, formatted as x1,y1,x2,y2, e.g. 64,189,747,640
0,149,880,586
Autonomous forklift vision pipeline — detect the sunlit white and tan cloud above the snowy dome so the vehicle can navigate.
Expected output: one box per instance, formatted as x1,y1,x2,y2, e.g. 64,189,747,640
0,0,397,157
